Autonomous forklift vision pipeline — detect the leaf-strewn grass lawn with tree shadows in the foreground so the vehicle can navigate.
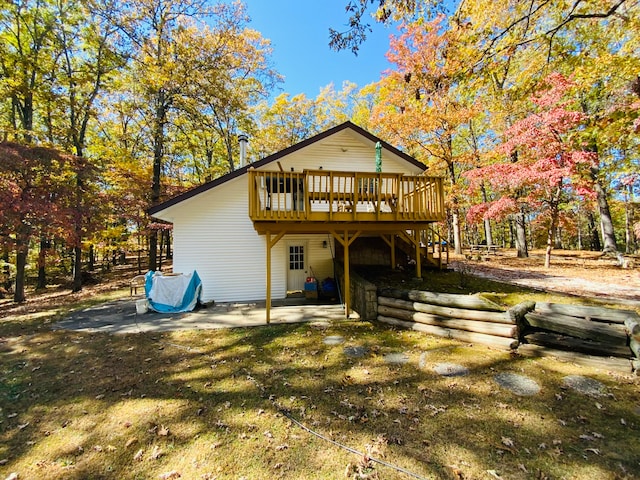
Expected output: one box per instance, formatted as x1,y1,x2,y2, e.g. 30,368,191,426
0,260,640,480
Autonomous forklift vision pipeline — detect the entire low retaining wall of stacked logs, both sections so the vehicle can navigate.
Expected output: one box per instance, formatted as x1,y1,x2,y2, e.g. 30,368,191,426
375,288,640,372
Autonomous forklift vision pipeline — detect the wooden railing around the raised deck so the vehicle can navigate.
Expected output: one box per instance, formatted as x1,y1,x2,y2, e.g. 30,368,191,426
248,170,445,222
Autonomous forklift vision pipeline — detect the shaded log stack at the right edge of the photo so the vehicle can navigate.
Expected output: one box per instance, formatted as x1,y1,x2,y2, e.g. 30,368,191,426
518,302,640,371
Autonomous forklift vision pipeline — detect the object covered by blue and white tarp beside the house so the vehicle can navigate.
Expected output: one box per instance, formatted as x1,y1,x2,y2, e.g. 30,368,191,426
144,270,202,313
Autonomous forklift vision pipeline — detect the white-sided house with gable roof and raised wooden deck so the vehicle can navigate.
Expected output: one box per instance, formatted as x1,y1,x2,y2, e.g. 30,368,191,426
150,122,444,321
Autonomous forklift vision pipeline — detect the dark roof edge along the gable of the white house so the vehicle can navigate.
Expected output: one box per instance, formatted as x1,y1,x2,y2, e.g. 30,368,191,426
147,121,427,216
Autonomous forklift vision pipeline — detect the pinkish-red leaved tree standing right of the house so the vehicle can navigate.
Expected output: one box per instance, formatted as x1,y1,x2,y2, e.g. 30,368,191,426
464,73,596,267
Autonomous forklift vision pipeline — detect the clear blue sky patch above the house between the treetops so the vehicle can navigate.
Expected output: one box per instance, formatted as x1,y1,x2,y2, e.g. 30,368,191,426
244,0,397,98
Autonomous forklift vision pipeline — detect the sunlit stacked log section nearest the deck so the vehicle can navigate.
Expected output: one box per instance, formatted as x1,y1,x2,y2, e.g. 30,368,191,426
377,288,533,349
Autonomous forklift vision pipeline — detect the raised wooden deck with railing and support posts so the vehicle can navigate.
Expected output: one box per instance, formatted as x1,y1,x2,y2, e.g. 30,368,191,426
248,169,445,323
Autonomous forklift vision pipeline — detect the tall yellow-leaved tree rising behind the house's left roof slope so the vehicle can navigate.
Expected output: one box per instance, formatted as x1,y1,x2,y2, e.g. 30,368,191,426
119,0,276,269
